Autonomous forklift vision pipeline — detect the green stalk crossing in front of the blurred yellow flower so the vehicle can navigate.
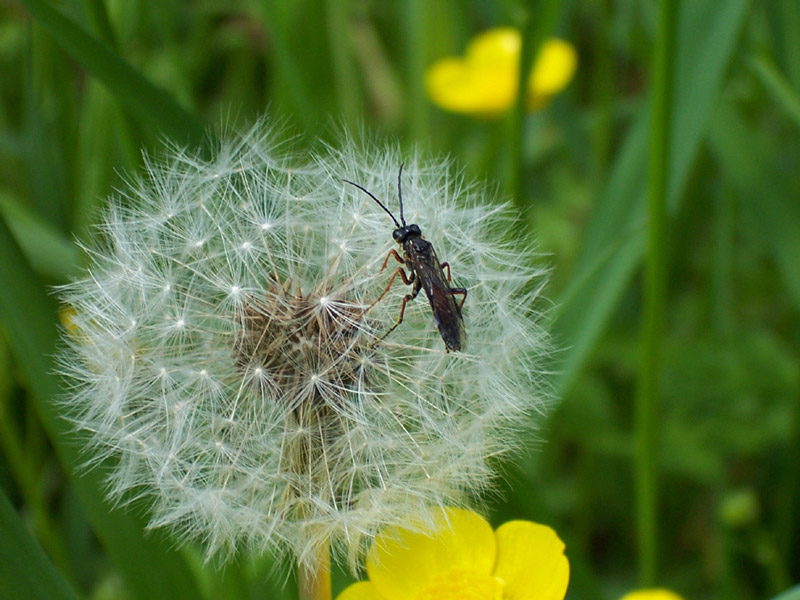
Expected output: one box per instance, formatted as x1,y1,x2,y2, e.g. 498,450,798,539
503,0,562,204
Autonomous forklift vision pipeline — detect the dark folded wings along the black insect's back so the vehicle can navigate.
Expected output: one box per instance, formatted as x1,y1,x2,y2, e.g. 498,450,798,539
409,246,467,350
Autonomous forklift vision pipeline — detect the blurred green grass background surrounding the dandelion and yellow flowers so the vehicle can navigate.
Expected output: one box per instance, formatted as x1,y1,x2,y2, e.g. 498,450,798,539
0,0,800,600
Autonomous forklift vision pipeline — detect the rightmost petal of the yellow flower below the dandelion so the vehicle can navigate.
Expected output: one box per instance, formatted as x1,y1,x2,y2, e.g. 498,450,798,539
494,521,569,600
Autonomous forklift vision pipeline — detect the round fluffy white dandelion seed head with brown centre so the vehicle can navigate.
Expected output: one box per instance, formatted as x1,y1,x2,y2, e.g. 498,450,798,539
62,123,544,565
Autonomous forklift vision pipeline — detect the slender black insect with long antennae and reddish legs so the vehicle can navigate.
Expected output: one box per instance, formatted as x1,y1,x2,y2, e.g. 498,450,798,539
344,165,467,352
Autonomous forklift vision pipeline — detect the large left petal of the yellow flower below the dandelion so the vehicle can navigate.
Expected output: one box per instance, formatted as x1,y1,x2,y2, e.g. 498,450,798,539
367,508,497,600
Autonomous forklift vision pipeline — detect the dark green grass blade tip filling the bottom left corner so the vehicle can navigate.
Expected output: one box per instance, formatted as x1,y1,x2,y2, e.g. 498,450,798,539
0,490,78,600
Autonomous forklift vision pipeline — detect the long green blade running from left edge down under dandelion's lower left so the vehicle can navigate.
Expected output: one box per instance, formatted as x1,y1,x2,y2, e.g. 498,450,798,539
0,221,200,600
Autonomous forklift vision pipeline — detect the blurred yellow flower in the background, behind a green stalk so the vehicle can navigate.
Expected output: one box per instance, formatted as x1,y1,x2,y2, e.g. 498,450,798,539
426,27,578,116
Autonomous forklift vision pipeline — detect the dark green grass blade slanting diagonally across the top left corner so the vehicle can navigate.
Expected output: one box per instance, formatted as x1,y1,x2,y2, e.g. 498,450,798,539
23,0,207,146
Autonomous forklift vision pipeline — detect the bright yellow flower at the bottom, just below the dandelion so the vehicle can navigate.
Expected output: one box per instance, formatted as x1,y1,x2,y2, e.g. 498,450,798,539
337,508,569,600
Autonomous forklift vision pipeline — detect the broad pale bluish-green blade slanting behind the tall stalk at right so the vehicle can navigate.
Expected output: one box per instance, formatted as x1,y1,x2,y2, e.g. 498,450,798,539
553,0,750,392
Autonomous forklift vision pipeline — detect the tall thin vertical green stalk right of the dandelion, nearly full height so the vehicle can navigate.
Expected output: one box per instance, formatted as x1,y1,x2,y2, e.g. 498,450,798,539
634,0,679,587
